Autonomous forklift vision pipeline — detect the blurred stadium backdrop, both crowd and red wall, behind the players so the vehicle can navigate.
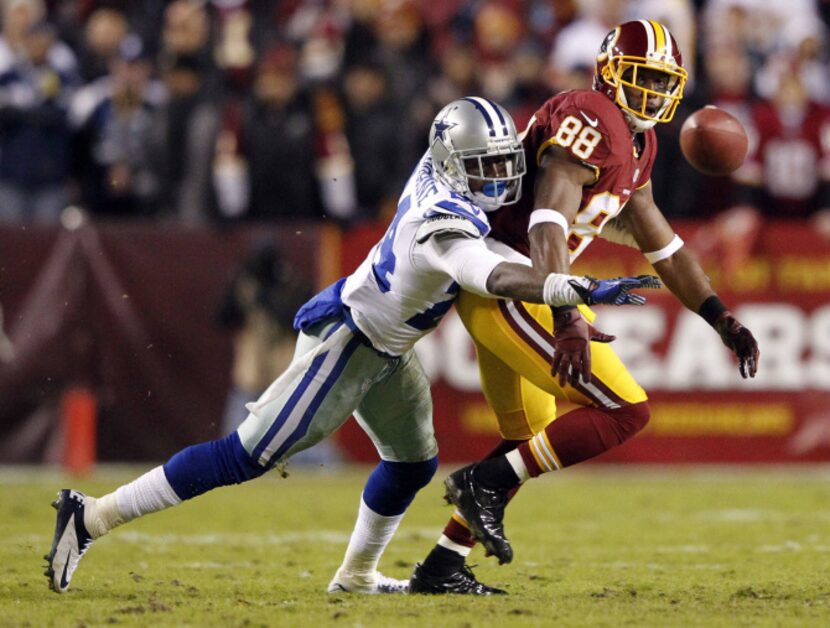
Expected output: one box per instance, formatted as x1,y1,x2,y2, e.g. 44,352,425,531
0,0,830,472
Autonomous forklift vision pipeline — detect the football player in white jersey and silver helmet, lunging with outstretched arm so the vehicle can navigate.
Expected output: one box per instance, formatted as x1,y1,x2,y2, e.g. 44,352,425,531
45,98,659,593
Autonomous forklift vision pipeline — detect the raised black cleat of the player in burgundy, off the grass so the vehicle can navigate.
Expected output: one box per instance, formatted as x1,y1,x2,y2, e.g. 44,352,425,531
444,465,513,565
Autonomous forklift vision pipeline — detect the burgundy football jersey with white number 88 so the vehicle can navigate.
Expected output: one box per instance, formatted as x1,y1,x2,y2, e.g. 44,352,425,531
490,90,657,261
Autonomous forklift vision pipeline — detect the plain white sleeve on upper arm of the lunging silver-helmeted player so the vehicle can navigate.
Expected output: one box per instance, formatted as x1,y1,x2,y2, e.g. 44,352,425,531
422,234,507,297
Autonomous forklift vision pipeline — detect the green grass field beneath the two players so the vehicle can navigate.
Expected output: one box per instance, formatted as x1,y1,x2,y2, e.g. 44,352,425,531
0,467,830,628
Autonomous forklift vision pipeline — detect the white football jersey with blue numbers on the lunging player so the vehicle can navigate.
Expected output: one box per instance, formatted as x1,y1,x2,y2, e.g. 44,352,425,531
342,152,503,355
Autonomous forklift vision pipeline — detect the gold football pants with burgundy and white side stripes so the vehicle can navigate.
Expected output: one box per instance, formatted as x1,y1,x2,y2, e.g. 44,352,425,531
456,290,648,440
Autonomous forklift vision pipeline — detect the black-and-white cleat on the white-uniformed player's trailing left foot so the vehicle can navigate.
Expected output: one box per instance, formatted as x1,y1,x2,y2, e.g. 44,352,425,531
43,488,94,593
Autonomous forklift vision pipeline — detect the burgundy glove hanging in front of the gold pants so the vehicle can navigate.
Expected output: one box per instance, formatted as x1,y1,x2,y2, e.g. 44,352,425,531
550,306,616,386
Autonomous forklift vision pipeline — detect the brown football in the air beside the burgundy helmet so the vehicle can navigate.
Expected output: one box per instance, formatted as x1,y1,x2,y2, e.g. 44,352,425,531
680,105,749,175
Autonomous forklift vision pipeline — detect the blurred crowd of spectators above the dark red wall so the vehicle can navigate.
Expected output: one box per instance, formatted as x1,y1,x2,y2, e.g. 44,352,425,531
0,0,830,233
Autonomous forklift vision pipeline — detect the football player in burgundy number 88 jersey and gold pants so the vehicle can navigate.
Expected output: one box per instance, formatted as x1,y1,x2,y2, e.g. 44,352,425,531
410,20,759,595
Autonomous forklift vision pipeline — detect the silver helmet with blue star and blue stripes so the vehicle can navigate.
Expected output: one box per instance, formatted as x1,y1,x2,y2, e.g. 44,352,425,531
429,97,525,211
